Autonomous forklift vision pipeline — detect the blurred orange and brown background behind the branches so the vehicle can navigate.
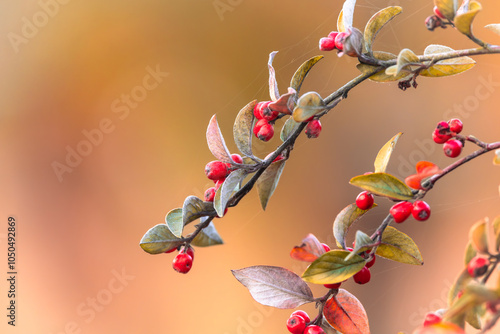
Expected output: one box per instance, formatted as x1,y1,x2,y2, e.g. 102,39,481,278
0,0,500,334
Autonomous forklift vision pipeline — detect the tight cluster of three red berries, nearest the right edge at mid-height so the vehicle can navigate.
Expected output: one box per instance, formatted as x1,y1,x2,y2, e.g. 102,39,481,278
432,118,464,158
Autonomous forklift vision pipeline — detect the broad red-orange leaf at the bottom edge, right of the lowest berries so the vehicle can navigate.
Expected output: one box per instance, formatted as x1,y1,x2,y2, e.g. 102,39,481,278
323,289,370,334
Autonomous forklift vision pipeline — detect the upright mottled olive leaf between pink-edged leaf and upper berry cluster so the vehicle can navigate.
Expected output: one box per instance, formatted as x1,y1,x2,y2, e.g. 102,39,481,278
233,100,257,157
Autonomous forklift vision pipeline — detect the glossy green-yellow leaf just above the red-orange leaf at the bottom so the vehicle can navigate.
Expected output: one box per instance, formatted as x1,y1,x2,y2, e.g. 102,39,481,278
302,250,365,284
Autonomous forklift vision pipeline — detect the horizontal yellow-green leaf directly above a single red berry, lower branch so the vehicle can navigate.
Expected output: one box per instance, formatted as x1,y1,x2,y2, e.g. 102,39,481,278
349,173,413,201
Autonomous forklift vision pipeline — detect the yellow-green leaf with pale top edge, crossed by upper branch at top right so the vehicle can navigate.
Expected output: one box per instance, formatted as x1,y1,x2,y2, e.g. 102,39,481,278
419,44,476,77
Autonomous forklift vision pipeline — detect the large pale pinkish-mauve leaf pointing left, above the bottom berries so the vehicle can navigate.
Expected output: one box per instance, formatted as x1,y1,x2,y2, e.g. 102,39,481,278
231,266,314,309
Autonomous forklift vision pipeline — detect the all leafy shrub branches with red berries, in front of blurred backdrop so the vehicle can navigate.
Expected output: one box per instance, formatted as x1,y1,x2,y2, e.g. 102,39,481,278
140,0,500,334
